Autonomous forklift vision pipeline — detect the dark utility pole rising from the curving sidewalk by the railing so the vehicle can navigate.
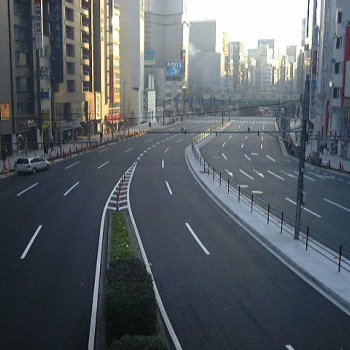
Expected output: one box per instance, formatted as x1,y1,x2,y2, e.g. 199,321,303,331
294,74,310,239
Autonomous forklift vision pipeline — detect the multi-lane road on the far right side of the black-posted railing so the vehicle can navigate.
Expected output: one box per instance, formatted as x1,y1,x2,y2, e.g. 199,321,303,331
201,118,350,254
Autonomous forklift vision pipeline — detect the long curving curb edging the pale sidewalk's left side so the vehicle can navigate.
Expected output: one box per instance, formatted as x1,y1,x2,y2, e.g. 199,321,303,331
185,145,350,316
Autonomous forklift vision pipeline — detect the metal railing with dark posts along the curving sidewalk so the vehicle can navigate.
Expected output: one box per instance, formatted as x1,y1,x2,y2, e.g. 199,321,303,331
192,138,350,273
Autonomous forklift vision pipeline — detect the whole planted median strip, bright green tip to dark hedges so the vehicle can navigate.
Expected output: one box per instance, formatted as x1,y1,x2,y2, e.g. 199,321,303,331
106,213,169,350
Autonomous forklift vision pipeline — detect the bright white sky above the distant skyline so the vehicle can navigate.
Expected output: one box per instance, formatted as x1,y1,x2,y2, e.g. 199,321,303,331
187,0,307,48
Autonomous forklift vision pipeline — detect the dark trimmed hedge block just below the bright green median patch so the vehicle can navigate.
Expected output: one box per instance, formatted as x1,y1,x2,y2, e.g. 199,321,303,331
106,258,157,343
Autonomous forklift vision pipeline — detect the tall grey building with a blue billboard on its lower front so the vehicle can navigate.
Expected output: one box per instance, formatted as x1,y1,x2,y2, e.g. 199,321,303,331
145,0,189,115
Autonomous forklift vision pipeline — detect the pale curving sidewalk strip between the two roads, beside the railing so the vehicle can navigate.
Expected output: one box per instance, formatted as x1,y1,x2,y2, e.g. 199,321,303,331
186,141,350,315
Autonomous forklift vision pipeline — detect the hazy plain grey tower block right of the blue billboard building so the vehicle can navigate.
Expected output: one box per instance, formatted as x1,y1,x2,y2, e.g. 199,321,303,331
189,20,224,95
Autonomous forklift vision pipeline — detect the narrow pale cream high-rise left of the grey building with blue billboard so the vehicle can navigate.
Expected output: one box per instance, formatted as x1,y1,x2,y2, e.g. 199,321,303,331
117,0,145,125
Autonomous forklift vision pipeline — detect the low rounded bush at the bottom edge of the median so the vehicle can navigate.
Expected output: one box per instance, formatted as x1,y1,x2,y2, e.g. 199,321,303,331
110,335,169,350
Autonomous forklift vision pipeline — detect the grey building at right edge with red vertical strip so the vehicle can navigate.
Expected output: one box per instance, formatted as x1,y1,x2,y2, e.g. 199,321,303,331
303,0,350,159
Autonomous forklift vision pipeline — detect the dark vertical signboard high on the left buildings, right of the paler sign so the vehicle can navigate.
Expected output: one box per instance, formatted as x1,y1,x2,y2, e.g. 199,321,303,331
51,0,63,83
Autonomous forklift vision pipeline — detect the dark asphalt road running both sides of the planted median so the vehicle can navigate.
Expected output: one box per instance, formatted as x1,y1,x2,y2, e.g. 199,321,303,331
0,120,350,350
